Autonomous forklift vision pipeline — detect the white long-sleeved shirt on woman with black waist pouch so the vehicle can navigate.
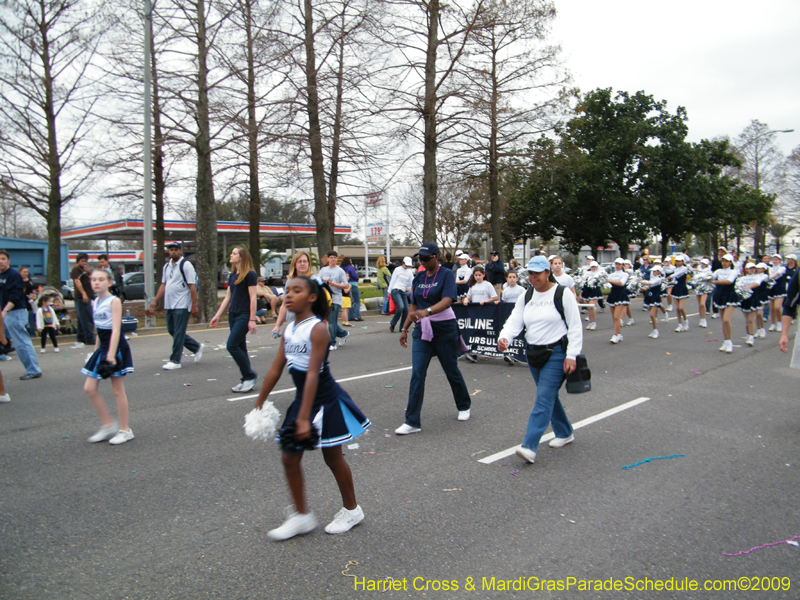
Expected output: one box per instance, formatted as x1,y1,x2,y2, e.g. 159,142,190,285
499,285,583,360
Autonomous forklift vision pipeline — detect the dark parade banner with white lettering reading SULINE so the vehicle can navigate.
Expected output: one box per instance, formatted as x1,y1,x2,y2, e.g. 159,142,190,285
453,302,528,364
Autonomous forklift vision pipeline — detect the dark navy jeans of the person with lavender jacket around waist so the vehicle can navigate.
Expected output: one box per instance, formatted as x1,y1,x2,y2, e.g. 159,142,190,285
405,327,472,427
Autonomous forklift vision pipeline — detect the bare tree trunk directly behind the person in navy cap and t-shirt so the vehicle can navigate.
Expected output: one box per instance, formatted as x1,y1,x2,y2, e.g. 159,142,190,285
422,0,439,242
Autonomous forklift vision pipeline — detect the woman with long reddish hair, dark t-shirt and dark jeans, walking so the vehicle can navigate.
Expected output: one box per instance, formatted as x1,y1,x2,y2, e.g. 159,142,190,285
208,247,258,392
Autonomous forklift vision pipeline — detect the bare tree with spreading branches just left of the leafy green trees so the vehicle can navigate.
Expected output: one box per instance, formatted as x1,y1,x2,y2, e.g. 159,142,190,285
450,0,569,257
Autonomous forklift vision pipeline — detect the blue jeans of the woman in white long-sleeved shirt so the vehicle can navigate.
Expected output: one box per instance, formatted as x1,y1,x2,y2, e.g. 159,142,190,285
522,347,572,452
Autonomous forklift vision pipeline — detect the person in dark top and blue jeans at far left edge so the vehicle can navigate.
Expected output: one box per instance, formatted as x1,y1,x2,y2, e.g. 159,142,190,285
0,250,42,381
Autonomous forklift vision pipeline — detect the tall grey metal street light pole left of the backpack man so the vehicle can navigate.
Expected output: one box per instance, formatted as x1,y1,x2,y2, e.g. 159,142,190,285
142,0,156,329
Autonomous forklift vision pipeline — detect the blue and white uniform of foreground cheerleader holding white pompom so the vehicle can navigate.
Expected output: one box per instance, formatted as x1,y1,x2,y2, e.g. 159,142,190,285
283,316,372,448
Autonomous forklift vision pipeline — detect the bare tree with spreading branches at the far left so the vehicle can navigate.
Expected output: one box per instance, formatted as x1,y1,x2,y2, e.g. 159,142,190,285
0,0,102,285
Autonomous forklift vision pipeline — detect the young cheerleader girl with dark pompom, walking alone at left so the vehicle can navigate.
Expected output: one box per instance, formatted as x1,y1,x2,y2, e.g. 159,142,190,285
81,269,133,445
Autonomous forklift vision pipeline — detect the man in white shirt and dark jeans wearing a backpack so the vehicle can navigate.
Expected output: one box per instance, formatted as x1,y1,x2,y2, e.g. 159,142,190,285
149,242,205,371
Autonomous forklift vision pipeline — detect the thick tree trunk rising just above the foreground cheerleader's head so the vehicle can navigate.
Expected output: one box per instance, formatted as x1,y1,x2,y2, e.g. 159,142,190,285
304,0,334,257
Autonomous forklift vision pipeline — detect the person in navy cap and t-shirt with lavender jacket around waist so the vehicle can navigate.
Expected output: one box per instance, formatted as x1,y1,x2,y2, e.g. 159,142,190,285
394,242,471,435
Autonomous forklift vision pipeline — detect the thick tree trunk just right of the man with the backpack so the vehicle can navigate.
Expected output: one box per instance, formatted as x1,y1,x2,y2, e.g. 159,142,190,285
195,0,218,321
